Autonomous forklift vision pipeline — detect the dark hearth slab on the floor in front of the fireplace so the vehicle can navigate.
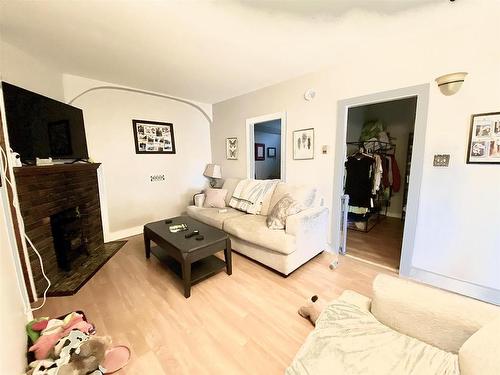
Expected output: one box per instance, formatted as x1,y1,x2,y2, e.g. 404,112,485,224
47,241,127,297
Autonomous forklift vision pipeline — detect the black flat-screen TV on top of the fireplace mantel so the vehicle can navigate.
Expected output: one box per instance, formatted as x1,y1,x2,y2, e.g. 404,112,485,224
2,82,89,162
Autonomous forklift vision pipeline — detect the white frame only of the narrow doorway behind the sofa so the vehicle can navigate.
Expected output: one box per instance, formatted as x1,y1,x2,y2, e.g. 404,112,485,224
246,112,287,182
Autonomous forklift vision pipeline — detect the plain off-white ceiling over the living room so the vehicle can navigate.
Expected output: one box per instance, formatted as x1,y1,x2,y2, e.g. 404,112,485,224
0,0,449,103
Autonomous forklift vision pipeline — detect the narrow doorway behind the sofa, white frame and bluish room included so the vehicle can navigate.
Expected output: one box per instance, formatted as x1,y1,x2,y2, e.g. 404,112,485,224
247,113,286,181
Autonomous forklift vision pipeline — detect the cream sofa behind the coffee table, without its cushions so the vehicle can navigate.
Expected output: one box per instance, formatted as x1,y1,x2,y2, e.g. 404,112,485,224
187,178,328,275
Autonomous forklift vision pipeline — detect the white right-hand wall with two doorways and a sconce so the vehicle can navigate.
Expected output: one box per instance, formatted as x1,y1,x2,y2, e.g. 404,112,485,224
211,2,500,304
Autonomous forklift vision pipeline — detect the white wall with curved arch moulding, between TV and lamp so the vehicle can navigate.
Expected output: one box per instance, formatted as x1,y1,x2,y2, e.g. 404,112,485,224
64,75,211,240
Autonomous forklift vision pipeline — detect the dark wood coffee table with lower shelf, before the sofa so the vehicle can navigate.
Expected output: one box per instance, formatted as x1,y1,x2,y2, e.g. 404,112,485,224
144,216,232,298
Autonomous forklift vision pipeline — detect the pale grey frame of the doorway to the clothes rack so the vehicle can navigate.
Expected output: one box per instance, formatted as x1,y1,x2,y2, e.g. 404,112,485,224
331,84,430,277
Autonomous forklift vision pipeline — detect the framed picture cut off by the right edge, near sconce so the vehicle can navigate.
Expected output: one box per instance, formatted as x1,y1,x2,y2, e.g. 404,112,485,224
467,112,500,164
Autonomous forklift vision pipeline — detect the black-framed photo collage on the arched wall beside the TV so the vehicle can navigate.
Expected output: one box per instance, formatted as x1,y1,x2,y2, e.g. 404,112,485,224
132,120,175,154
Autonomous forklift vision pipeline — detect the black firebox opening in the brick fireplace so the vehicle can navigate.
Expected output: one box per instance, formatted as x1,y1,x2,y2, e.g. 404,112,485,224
50,206,89,271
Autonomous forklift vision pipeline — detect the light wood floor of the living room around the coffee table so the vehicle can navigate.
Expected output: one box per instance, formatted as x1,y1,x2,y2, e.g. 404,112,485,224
36,236,387,375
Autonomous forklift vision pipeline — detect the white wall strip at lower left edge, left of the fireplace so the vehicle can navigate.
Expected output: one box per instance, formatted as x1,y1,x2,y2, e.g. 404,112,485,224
0,192,28,374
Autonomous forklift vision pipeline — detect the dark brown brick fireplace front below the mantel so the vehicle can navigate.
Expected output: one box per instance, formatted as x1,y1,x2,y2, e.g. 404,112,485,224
14,163,104,294
